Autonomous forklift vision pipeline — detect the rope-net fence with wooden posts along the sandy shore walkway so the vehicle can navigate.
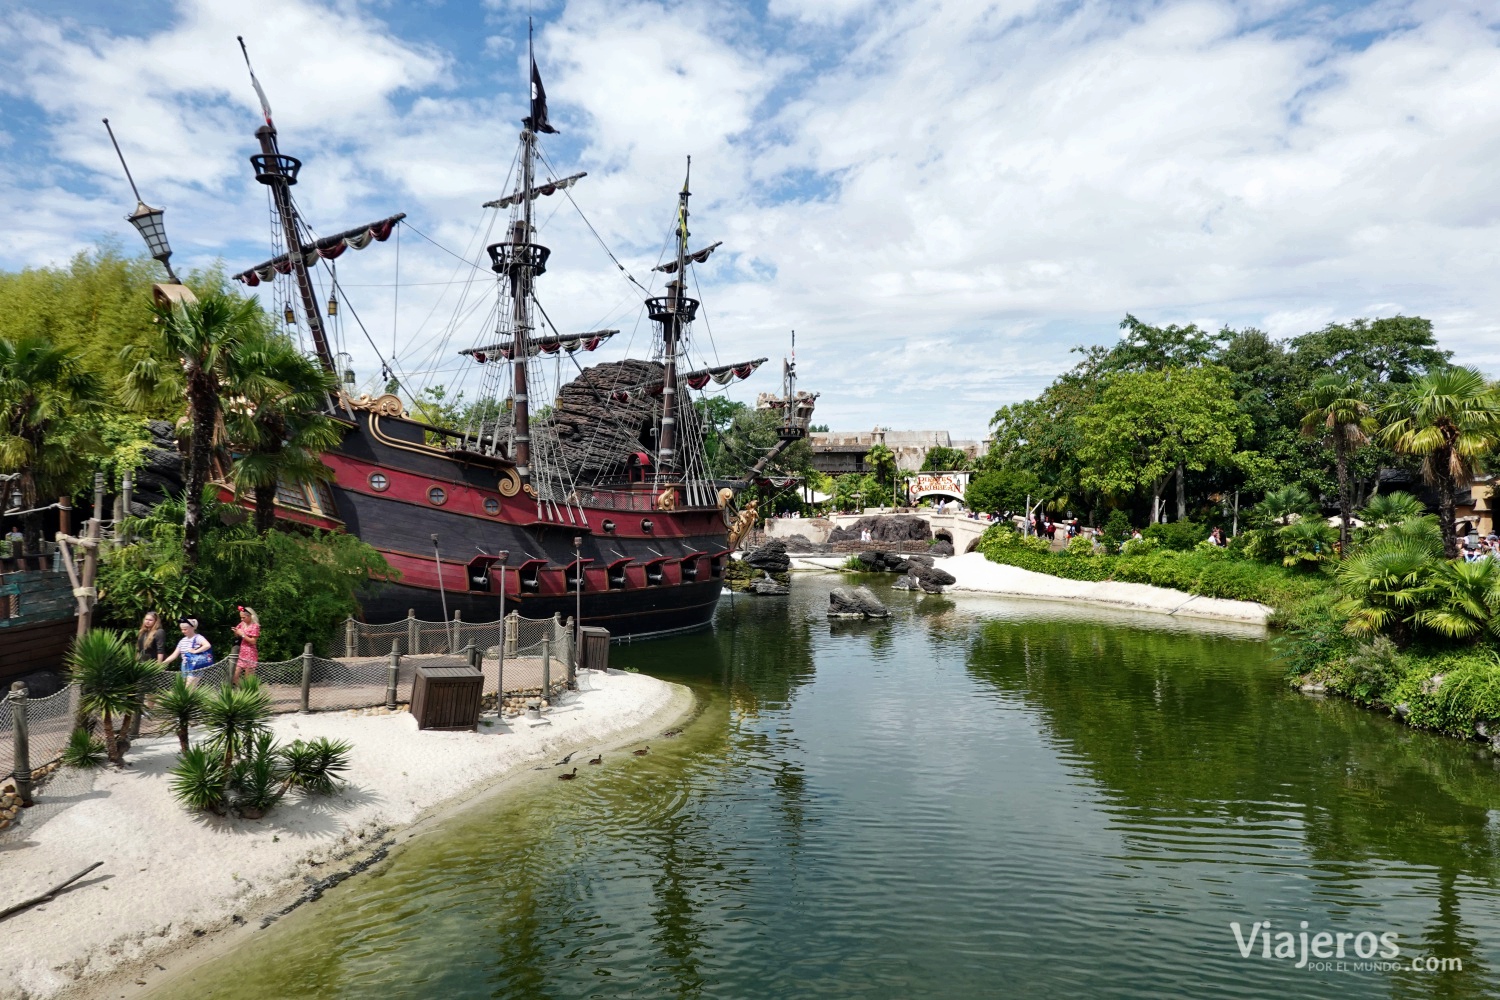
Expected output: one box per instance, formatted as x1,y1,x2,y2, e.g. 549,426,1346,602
0,612,578,777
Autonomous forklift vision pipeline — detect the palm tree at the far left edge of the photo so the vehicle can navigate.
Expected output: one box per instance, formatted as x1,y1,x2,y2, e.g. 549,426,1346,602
0,334,105,547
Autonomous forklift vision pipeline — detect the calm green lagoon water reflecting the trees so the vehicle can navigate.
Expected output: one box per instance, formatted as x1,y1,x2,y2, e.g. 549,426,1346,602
149,577,1500,999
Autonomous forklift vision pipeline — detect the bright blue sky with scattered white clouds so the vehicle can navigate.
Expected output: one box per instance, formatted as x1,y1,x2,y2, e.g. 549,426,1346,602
0,0,1500,436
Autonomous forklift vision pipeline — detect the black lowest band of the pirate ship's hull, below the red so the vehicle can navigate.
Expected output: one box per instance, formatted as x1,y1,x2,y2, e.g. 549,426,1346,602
360,580,723,639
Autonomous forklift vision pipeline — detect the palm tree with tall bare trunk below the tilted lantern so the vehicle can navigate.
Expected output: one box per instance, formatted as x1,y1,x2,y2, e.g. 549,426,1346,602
120,291,269,570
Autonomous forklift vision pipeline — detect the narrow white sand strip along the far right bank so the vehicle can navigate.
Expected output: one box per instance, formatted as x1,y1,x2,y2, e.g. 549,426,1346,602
938,552,1272,625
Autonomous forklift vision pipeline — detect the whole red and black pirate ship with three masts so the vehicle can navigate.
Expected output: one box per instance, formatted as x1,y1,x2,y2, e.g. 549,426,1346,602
150,40,816,637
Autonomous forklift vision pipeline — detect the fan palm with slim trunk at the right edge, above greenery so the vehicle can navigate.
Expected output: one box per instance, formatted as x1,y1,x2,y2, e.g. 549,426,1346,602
1380,366,1500,559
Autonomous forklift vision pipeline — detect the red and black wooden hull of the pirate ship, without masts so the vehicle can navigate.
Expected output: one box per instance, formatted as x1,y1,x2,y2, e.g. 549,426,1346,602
281,397,731,637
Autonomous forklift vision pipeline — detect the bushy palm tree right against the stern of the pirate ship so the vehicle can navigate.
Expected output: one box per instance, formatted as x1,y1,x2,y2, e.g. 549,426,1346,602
225,334,339,534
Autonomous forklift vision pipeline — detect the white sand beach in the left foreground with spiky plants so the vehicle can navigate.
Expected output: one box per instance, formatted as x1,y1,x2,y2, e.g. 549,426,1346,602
0,672,692,1000
